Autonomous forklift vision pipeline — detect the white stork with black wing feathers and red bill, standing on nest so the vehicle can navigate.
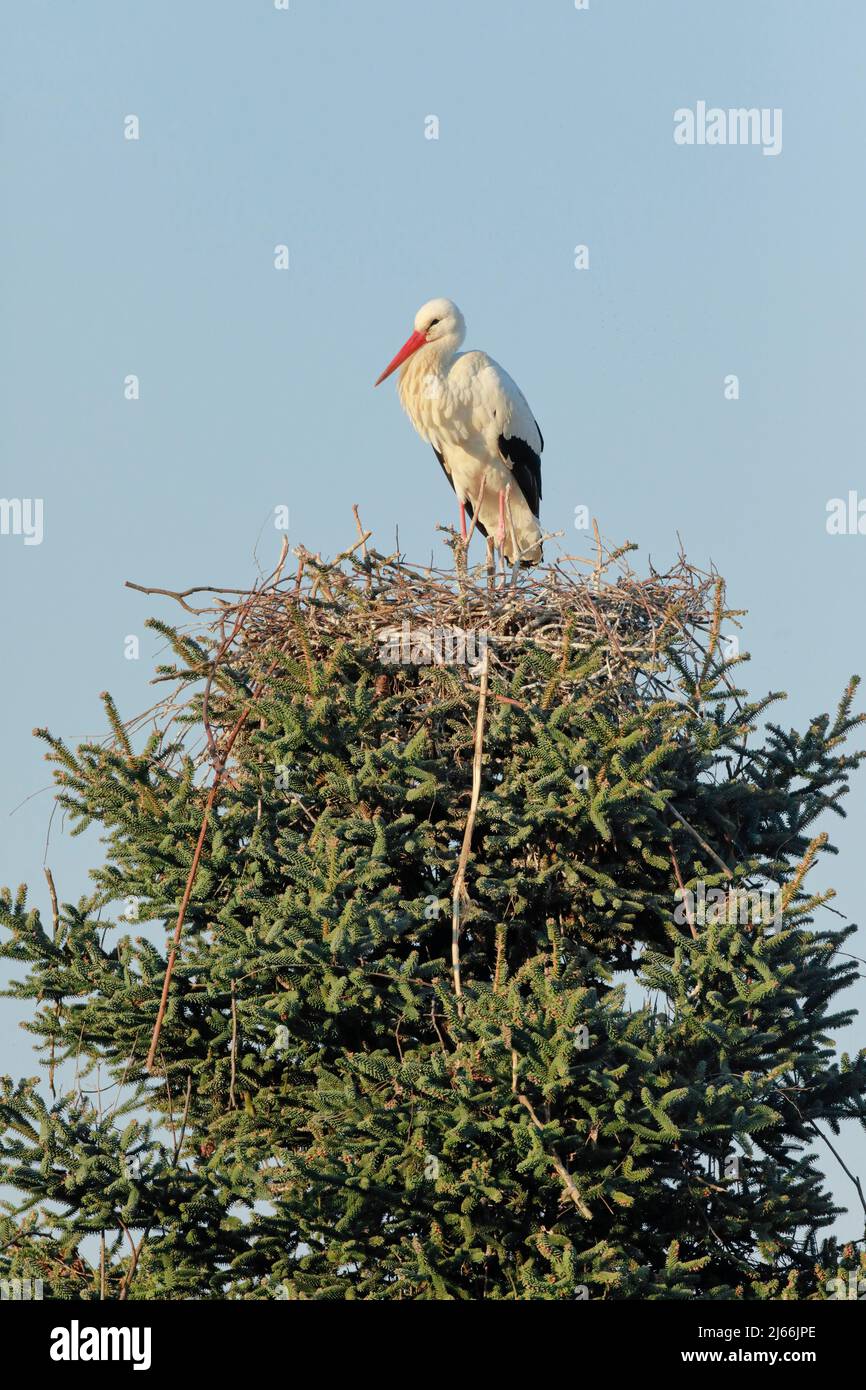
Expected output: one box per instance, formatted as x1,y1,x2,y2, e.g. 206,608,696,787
375,299,544,564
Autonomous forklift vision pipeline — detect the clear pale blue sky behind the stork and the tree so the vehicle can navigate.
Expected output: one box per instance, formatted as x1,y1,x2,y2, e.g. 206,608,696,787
0,0,866,1234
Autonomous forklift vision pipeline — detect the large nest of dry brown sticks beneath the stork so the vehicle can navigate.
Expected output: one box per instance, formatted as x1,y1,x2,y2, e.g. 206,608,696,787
125,524,740,763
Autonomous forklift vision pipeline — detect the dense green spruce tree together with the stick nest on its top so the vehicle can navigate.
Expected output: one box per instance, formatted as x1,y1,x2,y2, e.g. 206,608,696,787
0,536,866,1300
